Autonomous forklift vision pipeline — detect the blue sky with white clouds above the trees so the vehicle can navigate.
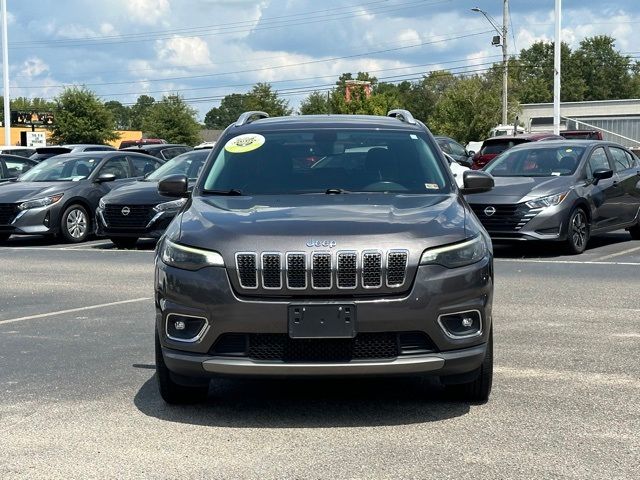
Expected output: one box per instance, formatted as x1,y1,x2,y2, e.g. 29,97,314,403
7,0,640,119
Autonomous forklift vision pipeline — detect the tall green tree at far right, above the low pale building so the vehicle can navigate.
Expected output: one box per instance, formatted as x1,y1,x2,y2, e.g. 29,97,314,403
575,35,633,100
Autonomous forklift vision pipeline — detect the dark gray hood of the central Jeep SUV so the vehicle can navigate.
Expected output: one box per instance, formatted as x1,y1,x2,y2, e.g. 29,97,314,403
179,194,466,259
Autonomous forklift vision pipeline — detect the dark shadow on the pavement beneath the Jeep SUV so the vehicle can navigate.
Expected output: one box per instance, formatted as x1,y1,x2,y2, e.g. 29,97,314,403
134,376,469,428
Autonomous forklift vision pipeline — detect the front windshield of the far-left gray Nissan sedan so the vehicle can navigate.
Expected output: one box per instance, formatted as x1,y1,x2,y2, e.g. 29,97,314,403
19,155,101,182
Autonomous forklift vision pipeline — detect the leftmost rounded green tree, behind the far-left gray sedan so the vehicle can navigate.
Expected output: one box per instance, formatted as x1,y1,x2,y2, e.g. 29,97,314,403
51,87,119,144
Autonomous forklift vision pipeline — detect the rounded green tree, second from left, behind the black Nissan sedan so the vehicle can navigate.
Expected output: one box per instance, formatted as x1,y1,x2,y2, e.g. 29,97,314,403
142,95,200,145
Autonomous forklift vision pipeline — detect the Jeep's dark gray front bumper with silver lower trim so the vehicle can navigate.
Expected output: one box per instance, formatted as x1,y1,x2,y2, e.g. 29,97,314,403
156,257,493,377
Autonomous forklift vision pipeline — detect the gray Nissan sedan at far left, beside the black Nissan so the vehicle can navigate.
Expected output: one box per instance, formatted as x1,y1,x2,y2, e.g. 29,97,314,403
0,150,162,243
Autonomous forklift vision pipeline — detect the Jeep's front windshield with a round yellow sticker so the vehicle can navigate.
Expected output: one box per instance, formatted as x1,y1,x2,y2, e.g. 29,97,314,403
204,129,451,195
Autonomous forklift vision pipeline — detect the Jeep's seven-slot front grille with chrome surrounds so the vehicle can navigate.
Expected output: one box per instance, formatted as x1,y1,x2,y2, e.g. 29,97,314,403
235,249,409,293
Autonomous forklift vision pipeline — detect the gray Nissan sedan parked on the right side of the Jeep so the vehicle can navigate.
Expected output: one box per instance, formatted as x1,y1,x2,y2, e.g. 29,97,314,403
467,140,640,254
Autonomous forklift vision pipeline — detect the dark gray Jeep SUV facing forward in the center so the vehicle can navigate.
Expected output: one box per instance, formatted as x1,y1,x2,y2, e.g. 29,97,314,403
155,110,493,403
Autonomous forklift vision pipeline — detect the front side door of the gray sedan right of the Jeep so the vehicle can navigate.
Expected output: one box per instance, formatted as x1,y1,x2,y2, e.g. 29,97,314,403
585,147,623,230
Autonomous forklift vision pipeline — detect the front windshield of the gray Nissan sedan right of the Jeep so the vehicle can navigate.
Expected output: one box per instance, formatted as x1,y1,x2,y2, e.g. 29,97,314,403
484,146,584,177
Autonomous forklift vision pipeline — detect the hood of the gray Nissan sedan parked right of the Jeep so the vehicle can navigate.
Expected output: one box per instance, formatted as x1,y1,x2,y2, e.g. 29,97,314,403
467,176,574,204
